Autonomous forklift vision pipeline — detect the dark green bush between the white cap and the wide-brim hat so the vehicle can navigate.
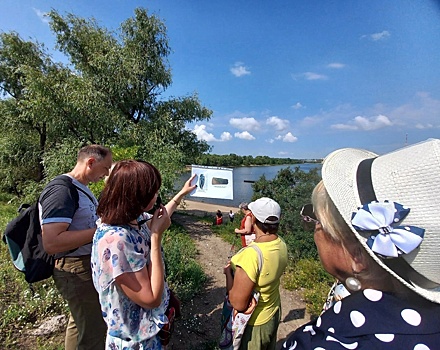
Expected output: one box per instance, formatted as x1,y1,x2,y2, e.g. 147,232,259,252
252,167,320,260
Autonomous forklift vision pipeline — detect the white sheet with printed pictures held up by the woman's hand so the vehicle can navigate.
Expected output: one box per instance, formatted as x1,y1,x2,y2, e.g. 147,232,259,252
190,165,234,199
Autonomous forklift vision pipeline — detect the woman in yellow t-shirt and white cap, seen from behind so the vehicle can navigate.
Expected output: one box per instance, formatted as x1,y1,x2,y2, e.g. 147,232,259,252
224,197,287,350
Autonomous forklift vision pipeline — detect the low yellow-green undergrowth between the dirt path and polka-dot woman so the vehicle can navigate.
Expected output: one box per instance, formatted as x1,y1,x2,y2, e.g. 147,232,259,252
283,258,334,316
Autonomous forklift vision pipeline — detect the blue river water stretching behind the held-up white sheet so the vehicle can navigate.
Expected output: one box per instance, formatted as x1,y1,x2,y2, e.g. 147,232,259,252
176,163,321,207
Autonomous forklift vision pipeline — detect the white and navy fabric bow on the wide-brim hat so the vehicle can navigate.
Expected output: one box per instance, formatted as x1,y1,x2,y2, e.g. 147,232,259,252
351,201,425,258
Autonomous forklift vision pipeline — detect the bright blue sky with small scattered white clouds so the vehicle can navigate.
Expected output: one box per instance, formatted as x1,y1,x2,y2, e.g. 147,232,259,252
0,0,440,158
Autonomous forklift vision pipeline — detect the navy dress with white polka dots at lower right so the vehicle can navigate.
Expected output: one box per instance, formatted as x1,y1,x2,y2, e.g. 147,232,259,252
282,289,440,350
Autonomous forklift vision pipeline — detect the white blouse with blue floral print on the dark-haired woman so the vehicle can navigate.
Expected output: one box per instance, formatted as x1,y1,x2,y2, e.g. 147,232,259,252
91,213,169,350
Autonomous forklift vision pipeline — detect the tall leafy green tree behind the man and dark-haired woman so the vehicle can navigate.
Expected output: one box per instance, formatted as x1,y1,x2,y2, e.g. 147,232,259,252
0,8,211,197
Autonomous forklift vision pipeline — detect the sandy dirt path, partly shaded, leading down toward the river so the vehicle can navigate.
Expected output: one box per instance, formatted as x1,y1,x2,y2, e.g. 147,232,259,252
168,211,309,350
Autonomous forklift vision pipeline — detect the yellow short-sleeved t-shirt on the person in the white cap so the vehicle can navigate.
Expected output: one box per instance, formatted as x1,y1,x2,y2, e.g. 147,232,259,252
231,237,287,326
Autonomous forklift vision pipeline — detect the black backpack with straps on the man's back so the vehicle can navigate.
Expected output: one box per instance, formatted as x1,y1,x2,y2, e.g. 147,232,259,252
3,175,94,283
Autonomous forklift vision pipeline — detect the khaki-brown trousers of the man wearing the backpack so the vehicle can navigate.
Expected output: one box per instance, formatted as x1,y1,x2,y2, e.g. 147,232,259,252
53,255,107,350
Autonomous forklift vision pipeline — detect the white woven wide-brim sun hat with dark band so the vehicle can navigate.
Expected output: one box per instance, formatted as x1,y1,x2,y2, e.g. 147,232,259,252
322,139,440,303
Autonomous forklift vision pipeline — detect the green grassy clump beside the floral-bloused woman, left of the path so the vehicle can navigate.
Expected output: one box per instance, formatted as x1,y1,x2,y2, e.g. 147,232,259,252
163,224,206,301
